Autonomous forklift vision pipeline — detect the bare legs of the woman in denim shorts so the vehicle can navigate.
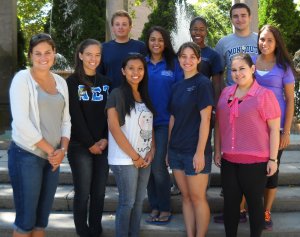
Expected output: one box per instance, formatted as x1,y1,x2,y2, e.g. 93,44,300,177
173,170,210,237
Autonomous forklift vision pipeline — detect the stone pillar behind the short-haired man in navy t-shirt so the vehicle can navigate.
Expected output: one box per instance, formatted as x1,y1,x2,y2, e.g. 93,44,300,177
105,0,128,41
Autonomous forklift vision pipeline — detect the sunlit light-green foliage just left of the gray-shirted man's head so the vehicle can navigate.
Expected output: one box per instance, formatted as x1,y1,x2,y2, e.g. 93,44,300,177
194,0,232,47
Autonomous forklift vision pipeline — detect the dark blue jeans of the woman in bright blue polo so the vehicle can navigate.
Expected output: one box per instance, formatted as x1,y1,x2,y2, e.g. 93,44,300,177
147,126,171,212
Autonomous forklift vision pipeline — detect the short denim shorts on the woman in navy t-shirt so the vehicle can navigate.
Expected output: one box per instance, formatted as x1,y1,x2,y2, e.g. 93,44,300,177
168,148,212,176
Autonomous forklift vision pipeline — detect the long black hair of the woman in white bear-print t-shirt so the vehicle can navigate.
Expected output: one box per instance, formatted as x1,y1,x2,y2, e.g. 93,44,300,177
120,54,154,115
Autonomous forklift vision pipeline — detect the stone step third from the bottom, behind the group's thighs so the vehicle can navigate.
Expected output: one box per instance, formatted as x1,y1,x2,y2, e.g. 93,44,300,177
0,150,300,186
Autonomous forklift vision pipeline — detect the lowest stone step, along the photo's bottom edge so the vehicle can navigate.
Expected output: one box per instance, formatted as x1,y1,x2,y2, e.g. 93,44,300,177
0,210,300,237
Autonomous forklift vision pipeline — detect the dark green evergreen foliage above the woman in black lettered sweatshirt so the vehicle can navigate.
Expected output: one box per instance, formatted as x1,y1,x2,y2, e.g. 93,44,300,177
51,0,106,65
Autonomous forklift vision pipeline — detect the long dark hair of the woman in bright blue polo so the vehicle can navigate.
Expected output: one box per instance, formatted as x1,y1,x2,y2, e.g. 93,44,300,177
145,26,176,70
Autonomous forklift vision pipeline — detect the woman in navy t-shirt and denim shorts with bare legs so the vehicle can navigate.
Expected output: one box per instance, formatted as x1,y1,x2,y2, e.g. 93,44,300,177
168,42,214,237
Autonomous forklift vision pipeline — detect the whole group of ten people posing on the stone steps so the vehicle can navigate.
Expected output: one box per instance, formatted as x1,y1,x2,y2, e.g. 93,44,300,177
8,3,294,237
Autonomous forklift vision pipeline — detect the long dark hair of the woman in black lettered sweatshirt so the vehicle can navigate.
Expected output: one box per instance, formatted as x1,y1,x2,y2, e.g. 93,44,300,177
74,39,102,90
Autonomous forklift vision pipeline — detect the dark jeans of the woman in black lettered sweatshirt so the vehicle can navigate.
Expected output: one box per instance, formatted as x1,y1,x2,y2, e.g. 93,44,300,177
68,142,109,237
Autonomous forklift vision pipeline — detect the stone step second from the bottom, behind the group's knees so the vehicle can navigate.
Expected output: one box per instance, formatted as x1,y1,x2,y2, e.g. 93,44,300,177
0,184,300,214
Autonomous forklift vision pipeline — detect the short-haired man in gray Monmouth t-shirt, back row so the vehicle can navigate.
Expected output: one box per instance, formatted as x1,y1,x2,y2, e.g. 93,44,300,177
215,3,258,86
